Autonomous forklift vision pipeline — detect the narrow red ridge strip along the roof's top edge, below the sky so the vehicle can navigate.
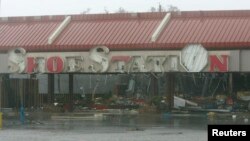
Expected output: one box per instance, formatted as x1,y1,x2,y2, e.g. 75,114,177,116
0,10,250,23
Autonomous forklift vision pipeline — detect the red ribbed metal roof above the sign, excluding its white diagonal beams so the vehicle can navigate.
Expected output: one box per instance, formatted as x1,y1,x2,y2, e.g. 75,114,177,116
0,10,250,52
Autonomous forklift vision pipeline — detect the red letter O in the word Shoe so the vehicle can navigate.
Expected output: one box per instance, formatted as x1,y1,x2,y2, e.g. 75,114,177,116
47,56,64,73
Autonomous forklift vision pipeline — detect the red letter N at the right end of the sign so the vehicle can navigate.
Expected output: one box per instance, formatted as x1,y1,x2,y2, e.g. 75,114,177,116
209,55,228,72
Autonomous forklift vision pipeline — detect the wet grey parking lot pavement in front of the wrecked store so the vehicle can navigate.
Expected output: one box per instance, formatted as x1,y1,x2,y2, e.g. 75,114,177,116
0,114,249,141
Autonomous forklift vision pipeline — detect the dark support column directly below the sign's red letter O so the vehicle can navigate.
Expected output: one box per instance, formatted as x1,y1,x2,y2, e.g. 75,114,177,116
48,74,55,104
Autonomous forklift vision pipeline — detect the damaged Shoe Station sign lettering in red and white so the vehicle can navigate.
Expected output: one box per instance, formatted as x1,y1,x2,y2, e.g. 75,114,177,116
6,45,229,73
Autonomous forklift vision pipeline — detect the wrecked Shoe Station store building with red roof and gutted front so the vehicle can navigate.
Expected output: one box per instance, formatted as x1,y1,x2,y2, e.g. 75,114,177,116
0,11,250,113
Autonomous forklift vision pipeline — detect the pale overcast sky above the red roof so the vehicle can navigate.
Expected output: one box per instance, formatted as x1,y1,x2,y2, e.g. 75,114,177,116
0,0,250,17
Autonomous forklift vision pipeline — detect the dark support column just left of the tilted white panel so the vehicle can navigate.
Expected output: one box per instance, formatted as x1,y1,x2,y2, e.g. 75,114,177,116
166,73,175,111
